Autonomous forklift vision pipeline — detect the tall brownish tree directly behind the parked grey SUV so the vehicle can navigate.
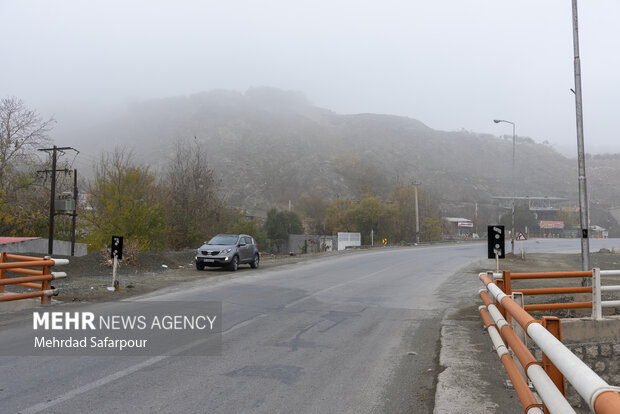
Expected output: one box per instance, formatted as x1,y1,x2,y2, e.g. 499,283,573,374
163,139,227,249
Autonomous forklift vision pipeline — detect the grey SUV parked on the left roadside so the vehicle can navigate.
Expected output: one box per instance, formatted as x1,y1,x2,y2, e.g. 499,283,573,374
196,234,260,271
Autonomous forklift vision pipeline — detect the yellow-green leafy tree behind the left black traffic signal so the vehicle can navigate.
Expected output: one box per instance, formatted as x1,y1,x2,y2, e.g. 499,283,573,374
84,148,165,251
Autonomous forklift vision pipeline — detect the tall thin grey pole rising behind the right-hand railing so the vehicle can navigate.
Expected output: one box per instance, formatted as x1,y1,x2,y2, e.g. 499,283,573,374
573,0,592,286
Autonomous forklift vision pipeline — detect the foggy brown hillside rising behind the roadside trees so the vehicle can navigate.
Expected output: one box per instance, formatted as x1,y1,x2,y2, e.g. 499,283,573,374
68,88,620,220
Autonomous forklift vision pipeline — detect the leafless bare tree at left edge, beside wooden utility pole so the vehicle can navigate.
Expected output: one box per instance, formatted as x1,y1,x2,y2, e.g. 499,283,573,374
0,97,56,191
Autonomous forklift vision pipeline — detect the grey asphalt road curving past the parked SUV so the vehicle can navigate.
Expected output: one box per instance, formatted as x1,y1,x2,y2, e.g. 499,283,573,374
0,240,620,413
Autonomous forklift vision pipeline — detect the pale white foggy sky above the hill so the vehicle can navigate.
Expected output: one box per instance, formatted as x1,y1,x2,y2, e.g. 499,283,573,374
0,0,620,156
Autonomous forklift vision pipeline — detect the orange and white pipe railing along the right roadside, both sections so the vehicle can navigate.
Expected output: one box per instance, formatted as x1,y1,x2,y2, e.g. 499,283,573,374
479,269,620,414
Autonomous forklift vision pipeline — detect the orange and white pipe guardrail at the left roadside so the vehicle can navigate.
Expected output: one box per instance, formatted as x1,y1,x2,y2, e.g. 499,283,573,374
0,252,69,304
